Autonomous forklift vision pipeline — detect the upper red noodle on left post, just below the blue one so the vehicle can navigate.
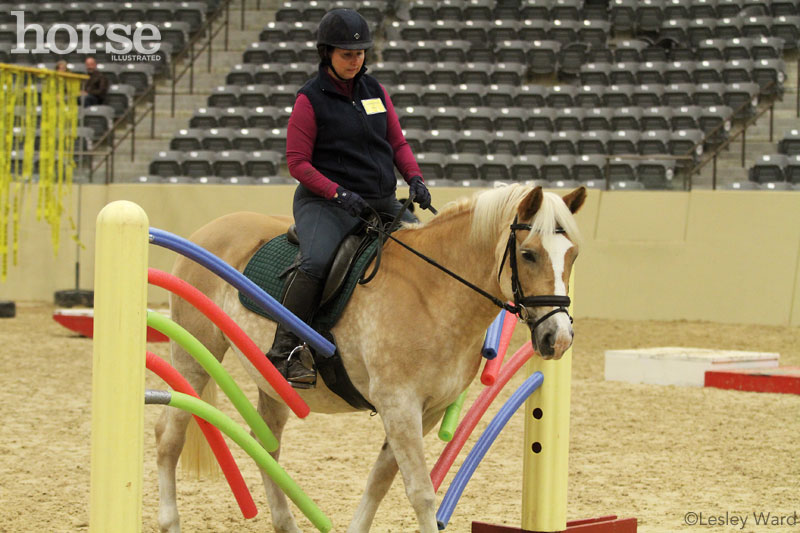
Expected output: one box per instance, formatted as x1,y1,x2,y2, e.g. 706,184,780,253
147,268,310,418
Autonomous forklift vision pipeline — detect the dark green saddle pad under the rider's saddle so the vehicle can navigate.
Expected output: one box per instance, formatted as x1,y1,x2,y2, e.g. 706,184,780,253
239,234,378,332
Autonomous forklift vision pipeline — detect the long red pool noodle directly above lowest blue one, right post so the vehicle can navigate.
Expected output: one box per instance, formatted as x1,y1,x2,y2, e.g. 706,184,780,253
431,342,533,492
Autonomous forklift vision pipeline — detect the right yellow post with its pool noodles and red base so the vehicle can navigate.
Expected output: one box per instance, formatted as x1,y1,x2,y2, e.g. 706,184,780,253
431,279,637,533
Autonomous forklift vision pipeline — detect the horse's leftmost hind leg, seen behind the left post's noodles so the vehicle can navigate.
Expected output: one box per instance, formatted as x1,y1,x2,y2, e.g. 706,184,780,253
156,305,228,533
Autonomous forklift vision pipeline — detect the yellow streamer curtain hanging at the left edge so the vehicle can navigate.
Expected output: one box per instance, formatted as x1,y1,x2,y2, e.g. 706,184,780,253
0,64,81,281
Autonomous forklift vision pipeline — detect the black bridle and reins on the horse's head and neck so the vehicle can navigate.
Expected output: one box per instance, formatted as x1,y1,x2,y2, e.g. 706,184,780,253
360,195,572,333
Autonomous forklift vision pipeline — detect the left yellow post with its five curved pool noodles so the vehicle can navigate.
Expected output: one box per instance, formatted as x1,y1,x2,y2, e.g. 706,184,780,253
89,201,334,533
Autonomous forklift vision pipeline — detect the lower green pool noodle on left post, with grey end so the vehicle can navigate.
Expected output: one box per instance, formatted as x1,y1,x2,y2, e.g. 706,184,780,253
162,391,333,533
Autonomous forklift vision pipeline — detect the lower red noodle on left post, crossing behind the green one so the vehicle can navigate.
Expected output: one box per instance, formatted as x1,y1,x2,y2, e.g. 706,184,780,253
145,352,258,518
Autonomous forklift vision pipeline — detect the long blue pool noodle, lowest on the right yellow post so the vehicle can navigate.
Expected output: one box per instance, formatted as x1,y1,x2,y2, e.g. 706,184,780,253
436,372,544,530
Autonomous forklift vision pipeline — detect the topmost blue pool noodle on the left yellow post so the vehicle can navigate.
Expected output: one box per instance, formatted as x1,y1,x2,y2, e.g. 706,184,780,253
150,228,336,357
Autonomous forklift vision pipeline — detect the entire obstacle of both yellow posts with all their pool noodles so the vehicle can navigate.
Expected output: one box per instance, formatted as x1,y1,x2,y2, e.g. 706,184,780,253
90,201,636,533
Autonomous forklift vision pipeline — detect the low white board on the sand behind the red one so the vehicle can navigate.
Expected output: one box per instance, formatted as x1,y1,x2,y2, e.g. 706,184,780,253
605,347,780,387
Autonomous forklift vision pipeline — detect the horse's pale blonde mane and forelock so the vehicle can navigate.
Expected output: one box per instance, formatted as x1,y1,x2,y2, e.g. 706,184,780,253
471,183,580,244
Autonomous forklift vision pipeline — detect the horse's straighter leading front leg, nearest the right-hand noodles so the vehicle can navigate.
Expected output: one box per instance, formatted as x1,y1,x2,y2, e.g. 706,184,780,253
378,395,438,533
